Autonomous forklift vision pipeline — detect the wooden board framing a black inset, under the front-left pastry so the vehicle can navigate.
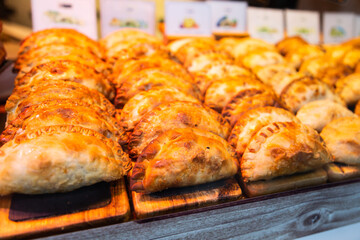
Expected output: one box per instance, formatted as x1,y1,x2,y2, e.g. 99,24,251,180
0,179,131,239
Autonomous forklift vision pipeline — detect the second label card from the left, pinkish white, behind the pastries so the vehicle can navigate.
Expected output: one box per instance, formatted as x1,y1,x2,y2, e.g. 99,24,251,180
100,0,155,37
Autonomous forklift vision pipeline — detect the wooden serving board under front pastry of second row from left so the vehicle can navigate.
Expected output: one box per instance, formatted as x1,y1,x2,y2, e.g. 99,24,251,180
131,178,243,219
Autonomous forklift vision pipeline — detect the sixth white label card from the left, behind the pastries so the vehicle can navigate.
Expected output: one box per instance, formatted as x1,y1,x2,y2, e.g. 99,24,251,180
285,10,320,44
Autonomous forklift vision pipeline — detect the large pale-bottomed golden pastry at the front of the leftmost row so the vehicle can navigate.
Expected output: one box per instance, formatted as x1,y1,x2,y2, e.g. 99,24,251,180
0,126,131,195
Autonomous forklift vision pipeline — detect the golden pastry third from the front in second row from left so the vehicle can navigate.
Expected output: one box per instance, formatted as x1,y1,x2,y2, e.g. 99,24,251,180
120,87,200,132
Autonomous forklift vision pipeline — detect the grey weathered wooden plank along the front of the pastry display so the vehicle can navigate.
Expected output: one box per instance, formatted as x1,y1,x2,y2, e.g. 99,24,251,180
42,180,360,239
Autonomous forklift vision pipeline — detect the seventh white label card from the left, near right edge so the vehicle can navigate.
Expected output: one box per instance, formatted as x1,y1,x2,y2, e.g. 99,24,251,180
323,12,355,43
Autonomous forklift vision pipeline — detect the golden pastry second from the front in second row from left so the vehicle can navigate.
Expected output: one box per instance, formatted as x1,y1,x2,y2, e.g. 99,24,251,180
128,101,231,158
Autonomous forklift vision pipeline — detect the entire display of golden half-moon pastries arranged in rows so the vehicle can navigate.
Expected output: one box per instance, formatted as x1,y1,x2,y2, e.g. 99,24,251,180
0,29,360,201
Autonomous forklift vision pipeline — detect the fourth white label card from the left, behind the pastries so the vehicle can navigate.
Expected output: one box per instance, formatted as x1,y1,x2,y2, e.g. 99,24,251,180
208,1,247,33
